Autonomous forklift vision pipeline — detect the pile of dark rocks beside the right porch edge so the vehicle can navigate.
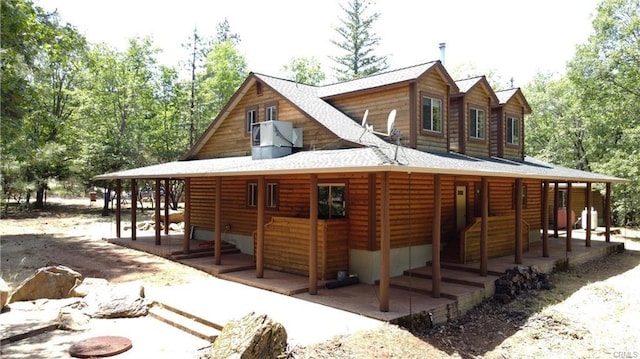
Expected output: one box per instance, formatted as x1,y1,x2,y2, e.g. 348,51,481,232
493,266,553,303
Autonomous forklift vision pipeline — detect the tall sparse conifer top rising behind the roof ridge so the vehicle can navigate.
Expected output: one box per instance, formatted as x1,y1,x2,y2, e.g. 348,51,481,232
331,0,389,81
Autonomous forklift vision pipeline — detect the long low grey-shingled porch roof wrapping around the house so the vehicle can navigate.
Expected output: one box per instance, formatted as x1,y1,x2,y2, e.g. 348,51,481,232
95,145,627,183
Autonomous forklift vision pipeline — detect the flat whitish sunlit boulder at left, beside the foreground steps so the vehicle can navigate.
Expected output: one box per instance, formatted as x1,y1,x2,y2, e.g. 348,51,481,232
82,283,151,318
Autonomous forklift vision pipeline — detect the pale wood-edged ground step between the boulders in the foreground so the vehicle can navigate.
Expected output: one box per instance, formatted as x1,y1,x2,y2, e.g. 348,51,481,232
149,304,222,343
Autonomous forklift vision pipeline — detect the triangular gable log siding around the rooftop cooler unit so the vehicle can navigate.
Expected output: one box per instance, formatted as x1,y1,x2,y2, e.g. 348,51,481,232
195,84,343,159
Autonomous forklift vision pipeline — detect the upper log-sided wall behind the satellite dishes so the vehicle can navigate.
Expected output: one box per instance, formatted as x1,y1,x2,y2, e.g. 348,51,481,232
328,85,409,141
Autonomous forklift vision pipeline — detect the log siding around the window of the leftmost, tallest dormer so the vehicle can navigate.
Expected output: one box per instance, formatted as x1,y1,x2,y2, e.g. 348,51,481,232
416,70,449,152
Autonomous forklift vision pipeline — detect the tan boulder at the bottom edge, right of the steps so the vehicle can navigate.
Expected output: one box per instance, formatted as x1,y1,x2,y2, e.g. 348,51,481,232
211,313,287,359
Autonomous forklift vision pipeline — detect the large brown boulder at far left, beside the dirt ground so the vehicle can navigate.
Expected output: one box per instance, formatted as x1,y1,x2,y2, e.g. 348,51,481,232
9,265,82,303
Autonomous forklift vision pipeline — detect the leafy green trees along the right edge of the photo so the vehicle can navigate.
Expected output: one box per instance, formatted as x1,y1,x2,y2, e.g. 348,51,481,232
525,0,640,223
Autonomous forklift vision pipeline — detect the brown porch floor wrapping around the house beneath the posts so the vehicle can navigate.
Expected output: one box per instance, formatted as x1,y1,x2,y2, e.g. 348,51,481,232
108,230,624,322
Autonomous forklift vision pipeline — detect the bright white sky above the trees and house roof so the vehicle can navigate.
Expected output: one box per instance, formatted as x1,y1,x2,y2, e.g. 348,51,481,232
35,0,598,86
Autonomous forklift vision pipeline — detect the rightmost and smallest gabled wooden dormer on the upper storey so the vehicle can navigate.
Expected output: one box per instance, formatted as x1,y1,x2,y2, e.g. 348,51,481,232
491,88,531,161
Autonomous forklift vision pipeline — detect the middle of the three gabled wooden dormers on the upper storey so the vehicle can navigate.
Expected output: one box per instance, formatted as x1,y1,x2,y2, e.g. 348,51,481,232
449,76,498,157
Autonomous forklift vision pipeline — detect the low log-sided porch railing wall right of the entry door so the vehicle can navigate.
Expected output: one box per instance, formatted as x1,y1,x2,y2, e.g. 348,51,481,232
463,215,530,263
